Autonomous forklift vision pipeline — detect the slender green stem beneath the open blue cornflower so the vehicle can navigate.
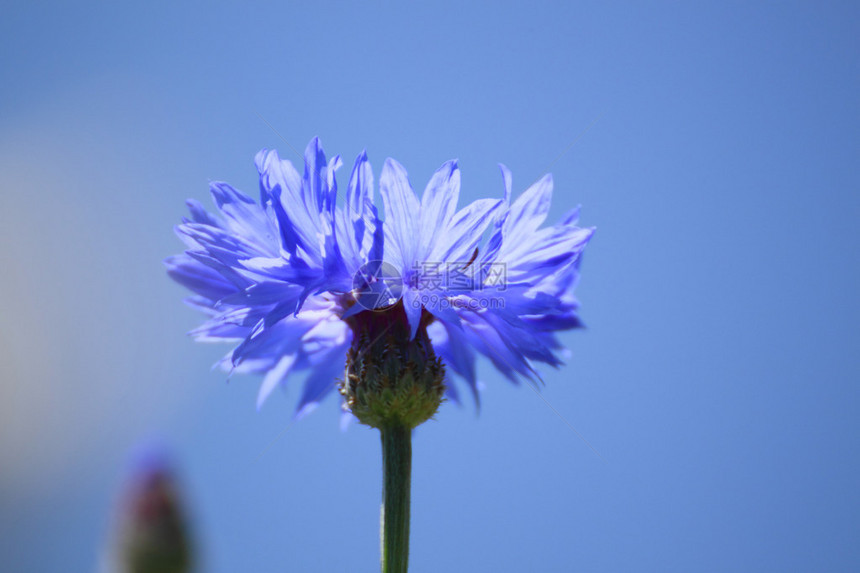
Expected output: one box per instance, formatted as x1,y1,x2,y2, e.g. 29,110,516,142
380,426,412,573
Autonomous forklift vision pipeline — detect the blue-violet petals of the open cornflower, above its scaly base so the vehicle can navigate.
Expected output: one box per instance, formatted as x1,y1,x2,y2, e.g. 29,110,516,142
166,139,593,415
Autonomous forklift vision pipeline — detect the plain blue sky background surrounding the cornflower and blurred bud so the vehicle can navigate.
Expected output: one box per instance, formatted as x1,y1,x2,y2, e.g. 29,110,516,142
0,1,860,573
